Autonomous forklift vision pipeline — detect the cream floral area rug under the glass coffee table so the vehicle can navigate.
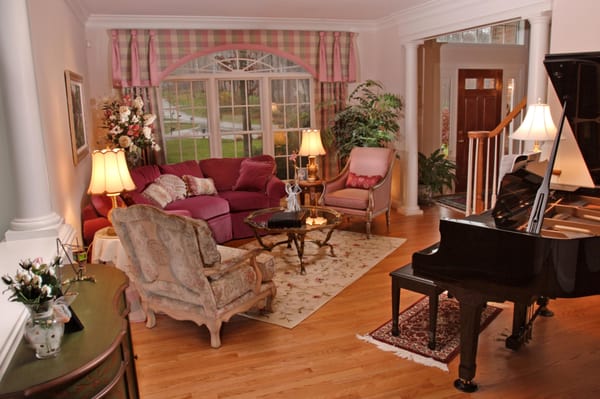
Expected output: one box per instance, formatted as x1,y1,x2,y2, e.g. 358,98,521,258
242,230,406,328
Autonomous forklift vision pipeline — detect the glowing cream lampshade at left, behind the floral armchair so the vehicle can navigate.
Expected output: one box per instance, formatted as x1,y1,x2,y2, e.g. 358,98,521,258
88,148,135,195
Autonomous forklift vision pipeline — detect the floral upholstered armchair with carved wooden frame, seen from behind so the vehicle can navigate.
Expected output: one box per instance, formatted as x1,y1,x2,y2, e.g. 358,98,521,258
112,205,276,348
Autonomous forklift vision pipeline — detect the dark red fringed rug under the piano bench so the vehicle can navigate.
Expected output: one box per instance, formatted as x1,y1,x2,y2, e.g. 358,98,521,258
358,294,502,371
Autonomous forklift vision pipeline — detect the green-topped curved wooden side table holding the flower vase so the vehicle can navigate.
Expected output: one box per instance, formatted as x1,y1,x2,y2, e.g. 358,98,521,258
0,264,139,399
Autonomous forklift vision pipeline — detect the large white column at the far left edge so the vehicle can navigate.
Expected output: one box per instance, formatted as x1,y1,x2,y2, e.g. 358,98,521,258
0,0,63,241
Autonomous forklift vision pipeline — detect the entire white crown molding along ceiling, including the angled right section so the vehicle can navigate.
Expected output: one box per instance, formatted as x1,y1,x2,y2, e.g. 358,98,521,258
79,0,553,38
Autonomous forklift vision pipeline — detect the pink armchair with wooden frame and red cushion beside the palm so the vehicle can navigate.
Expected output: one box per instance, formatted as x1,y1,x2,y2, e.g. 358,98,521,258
319,147,396,238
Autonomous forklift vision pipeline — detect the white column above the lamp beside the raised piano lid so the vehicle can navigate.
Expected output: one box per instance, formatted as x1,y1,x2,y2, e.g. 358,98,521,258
527,15,550,104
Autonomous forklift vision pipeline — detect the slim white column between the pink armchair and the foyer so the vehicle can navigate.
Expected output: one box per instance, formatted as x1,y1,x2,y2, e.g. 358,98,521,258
399,42,423,215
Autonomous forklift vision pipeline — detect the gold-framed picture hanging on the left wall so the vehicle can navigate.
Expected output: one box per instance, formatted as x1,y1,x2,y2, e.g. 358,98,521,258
65,70,89,165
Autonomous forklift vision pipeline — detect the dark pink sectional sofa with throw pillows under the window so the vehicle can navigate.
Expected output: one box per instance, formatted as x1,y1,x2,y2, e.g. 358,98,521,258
83,155,285,244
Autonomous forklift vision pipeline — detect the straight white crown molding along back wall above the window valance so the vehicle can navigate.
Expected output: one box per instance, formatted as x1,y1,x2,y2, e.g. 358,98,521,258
85,15,376,32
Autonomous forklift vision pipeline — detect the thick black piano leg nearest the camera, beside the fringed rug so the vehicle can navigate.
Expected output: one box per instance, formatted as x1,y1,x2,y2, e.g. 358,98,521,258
452,289,486,392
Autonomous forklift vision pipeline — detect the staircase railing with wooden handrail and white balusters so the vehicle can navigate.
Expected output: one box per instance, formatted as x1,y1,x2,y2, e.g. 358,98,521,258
465,98,527,216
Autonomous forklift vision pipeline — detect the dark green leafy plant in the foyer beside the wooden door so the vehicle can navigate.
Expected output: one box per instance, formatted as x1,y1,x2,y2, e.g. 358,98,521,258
418,148,456,204
